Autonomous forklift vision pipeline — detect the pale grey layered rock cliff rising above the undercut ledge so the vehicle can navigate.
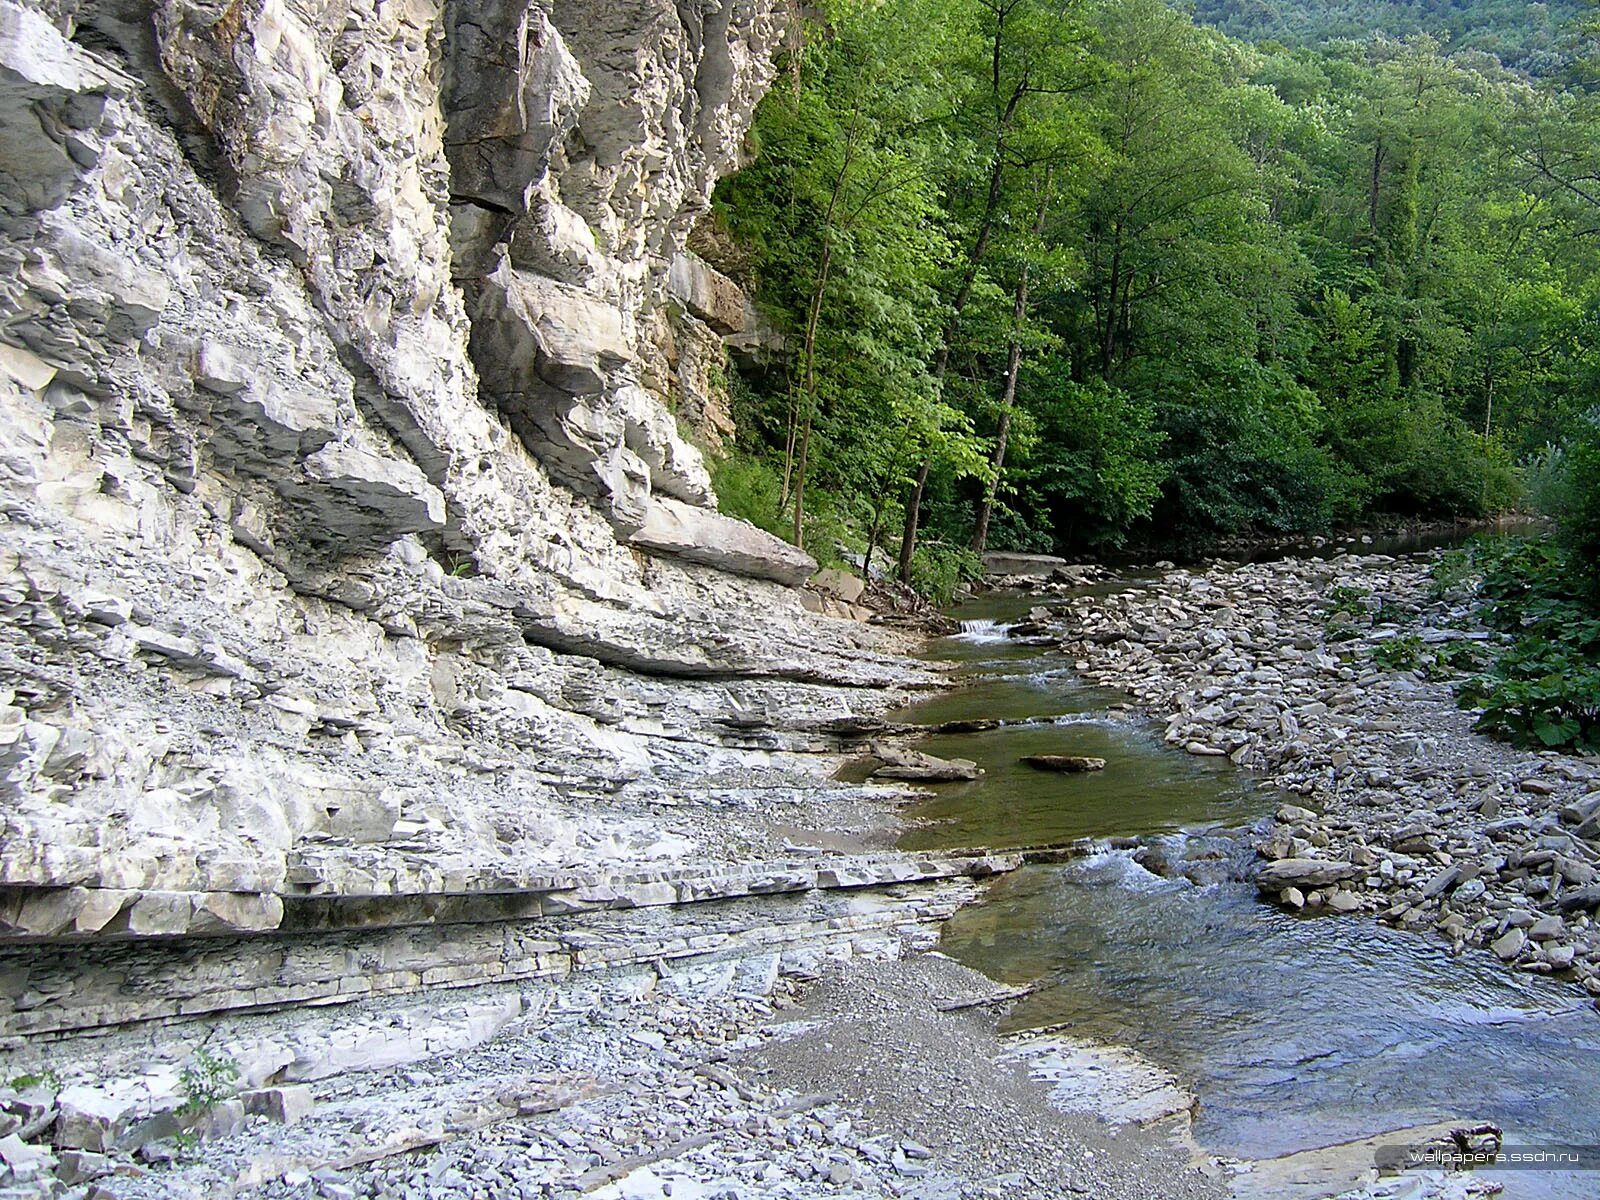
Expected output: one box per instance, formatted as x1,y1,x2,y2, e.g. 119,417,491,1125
0,0,922,979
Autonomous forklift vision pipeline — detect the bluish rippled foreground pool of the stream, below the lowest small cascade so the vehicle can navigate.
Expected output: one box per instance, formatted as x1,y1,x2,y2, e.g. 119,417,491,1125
942,853,1600,1200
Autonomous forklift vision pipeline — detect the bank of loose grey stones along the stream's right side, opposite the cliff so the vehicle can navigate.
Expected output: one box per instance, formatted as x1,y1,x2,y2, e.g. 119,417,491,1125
1050,555,1600,995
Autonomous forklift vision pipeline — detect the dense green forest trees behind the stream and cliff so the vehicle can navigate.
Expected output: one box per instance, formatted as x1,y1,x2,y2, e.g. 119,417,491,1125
707,0,1600,579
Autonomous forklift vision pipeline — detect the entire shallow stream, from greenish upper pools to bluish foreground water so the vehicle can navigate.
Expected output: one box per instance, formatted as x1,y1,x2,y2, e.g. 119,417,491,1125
898,611,1600,1200
